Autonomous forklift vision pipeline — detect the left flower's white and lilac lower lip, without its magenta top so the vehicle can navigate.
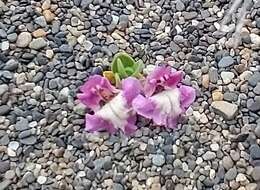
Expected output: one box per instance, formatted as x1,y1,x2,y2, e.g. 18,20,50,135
83,77,141,134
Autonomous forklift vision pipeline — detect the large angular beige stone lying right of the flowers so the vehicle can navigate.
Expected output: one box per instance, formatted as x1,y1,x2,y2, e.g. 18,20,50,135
212,101,238,120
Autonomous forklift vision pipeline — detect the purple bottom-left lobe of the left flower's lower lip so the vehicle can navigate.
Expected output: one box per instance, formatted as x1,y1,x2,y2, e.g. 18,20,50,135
85,114,116,133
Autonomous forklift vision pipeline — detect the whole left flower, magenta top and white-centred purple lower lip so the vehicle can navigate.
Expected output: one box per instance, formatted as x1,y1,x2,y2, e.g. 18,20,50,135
78,75,141,134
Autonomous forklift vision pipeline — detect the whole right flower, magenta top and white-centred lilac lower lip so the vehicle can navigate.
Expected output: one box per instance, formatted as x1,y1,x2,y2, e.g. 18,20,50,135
132,67,196,128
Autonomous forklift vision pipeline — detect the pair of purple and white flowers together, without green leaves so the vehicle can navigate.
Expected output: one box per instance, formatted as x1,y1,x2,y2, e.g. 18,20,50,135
78,63,196,135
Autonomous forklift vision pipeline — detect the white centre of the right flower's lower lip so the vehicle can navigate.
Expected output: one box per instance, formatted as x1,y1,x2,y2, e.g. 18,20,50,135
151,88,182,117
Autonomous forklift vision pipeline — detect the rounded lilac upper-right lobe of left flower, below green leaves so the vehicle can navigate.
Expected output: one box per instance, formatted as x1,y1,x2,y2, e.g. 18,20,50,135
122,77,141,105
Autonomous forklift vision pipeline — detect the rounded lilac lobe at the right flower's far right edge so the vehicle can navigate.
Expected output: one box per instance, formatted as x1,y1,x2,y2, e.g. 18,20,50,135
179,85,196,109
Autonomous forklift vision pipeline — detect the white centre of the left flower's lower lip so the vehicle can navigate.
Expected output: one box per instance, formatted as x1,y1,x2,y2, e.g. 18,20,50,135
96,93,130,129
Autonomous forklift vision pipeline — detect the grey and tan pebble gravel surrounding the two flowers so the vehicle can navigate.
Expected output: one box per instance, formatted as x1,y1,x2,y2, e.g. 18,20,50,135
0,0,260,190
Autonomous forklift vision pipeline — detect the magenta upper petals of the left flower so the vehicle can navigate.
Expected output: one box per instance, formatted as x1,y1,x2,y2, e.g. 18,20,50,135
77,75,118,111
